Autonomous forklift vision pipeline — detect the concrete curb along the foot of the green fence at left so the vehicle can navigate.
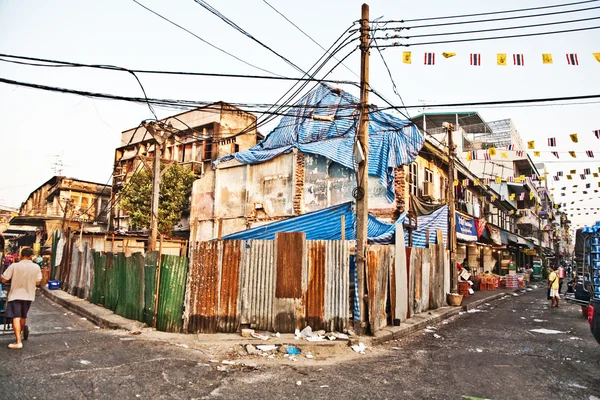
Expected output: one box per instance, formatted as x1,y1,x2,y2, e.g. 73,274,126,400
40,287,146,331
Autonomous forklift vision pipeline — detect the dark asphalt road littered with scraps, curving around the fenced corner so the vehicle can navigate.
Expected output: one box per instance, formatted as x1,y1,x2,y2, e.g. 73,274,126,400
0,289,600,400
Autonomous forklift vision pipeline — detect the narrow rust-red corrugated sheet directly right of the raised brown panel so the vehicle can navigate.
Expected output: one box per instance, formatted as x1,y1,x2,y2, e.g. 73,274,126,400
306,240,326,330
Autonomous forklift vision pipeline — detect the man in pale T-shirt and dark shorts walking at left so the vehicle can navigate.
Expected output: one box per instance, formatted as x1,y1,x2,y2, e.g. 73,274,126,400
0,247,42,349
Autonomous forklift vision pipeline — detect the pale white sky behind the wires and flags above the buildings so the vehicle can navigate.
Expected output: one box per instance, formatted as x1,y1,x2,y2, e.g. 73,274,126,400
0,0,600,230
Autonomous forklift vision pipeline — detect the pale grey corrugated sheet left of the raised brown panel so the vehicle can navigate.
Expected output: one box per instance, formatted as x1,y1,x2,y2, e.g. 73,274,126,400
240,240,275,330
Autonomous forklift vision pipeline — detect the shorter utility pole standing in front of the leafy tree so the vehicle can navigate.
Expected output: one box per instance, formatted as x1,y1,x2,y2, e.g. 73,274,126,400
143,121,173,251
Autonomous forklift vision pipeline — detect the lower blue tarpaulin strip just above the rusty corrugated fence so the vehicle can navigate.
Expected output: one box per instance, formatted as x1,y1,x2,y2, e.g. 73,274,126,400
223,202,448,247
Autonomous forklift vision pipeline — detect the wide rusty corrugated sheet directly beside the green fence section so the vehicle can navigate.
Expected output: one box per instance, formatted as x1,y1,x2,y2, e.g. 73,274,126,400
185,241,221,333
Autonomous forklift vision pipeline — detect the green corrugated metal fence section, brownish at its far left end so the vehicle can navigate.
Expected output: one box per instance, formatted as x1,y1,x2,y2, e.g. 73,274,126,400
52,233,188,332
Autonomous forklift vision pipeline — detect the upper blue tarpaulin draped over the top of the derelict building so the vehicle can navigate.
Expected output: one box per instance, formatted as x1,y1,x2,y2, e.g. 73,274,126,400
215,84,425,201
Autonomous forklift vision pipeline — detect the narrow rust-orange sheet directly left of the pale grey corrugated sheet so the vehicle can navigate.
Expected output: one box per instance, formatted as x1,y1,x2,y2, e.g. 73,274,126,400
217,240,242,332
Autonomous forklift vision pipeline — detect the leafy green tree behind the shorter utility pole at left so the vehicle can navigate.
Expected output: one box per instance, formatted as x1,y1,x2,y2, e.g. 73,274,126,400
121,165,196,235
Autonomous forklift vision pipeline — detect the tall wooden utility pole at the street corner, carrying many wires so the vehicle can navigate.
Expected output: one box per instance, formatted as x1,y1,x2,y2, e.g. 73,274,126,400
354,4,370,334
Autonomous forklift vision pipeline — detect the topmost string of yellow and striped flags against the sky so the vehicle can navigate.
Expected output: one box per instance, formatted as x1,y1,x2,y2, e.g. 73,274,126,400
402,51,600,67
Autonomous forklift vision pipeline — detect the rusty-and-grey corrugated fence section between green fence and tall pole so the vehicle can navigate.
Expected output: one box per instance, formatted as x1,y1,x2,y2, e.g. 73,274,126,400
184,233,349,333
